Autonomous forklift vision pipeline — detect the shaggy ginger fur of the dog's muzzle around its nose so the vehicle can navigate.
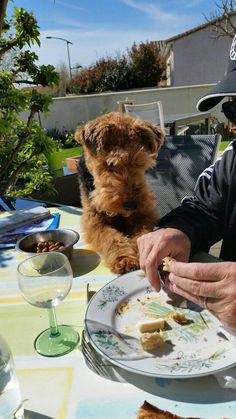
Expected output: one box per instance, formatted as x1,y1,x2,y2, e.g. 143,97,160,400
87,147,158,217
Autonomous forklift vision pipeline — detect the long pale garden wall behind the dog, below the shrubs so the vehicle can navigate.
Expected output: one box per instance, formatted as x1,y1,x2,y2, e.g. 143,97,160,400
35,84,225,130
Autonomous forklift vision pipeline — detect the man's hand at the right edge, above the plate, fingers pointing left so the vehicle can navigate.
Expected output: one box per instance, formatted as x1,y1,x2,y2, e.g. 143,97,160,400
169,262,236,332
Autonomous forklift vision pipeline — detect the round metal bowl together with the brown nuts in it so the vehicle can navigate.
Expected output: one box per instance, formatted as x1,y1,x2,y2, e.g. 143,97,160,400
16,228,80,259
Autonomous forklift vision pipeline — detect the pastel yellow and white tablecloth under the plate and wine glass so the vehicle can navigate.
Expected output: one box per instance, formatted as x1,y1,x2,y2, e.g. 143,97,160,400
0,201,236,419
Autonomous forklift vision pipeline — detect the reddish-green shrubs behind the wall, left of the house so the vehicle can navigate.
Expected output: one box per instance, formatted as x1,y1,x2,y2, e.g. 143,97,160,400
68,42,165,94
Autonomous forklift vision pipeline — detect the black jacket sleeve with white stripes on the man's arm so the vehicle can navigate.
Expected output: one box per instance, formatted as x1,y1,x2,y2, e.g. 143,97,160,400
158,140,236,253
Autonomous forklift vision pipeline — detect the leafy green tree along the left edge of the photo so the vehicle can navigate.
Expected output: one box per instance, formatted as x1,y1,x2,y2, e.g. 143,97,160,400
0,8,58,196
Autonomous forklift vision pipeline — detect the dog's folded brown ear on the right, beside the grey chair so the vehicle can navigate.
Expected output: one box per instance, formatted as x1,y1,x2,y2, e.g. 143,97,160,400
133,119,164,154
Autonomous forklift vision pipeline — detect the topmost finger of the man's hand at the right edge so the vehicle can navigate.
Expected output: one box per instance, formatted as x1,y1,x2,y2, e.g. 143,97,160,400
171,262,227,282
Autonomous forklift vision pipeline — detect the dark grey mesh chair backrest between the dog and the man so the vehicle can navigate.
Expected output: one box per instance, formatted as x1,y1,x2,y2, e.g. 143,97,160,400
146,134,221,216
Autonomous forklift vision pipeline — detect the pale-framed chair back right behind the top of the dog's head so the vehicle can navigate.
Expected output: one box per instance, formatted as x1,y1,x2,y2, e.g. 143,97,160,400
124,100,166,132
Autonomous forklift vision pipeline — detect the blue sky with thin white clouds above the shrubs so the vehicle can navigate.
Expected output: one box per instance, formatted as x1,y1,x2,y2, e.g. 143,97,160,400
7,0,221,71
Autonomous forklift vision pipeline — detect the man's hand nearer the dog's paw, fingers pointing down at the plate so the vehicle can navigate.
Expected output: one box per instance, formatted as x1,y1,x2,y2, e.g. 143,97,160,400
137,228,191,291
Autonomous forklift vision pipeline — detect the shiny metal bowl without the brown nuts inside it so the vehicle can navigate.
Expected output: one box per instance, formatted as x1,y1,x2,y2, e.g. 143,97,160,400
16,228,80,259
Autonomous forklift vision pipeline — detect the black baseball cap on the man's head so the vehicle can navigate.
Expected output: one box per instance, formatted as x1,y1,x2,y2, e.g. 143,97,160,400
197,35,236,112
